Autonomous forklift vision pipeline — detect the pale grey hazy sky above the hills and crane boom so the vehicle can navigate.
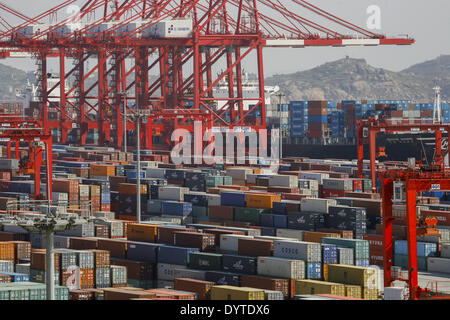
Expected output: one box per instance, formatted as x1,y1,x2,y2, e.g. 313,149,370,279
0,0,450,76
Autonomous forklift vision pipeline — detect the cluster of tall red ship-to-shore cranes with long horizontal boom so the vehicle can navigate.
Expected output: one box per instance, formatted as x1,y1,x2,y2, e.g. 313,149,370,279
0,0,414,148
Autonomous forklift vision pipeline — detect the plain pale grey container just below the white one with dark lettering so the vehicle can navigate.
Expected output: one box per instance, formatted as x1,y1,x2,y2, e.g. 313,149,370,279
257,257,305,279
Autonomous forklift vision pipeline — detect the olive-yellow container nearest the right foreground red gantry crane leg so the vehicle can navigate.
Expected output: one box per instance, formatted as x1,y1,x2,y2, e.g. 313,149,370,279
328,264,378,289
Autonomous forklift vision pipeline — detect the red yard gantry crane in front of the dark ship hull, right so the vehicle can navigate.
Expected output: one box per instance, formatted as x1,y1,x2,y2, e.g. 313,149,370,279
356,118,450,193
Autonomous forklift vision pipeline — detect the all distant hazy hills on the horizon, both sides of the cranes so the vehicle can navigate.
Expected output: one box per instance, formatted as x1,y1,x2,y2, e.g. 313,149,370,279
0,55,450,102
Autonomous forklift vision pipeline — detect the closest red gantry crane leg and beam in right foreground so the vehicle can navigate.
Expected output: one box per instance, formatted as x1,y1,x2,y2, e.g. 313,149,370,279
379,166,450,300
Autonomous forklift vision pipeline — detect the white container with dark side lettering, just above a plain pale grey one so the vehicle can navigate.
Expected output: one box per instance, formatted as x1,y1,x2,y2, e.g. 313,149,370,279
273,240,322,262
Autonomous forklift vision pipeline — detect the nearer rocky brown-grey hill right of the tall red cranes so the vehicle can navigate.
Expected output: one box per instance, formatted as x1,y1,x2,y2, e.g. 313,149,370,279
266,58,450,102
